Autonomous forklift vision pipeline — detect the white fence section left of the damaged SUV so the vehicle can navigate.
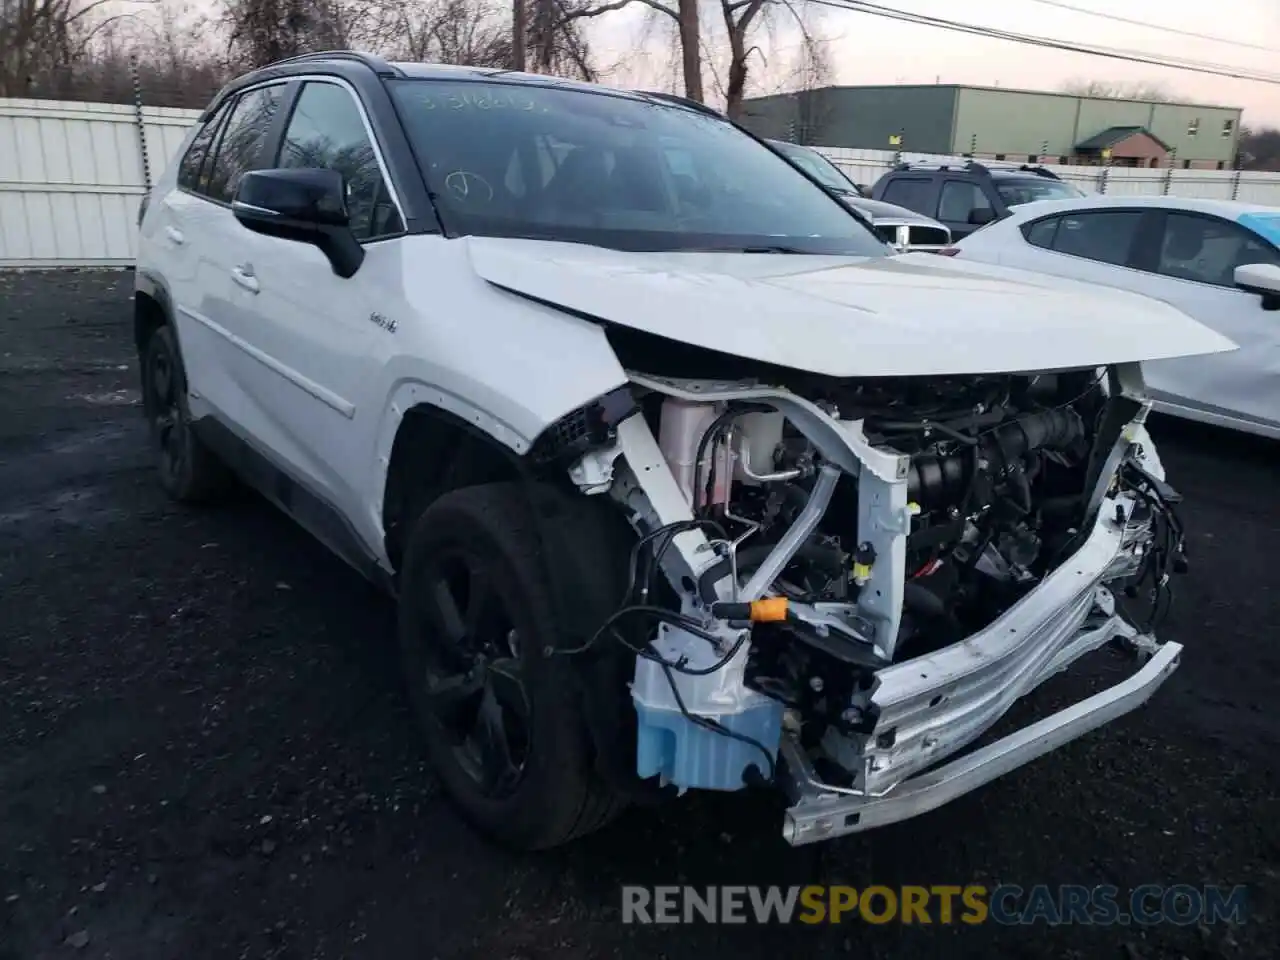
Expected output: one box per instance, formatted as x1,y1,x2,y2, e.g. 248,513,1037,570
0,99,200,268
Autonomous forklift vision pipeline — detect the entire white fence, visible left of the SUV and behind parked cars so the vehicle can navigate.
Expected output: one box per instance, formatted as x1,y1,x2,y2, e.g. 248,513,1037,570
0,99,1280,268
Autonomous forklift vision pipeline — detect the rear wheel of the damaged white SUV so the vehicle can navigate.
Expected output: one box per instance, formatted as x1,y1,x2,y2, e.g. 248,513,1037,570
142,326,232,503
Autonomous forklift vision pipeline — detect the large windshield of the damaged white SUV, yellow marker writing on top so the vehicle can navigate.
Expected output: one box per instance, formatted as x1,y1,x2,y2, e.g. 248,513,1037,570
390,79,886,256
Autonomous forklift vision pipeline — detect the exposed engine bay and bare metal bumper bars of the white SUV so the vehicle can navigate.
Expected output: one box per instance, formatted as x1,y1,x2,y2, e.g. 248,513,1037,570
550,365,1185,842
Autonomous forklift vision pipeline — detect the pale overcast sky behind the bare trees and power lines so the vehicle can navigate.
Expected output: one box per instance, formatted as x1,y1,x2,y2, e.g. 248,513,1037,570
593,0,1280,125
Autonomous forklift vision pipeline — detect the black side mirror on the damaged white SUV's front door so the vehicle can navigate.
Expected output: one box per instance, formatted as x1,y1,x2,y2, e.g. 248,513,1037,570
232,169,365,279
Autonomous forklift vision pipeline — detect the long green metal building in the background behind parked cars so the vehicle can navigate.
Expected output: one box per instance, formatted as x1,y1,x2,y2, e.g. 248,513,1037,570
741,83,1240,168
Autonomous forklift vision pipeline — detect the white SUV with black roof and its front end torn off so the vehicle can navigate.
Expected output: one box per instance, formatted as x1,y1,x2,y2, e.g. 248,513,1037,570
136,52,1234,849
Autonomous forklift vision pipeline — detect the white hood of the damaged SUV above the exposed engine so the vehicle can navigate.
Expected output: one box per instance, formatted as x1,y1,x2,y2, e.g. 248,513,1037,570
462,237,1235,376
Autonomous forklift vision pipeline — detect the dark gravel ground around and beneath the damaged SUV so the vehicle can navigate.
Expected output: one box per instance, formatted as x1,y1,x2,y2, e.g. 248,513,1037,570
0,271,1280,960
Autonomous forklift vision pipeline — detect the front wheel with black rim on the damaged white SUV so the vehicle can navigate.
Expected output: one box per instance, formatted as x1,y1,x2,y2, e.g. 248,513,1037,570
399,483,623,850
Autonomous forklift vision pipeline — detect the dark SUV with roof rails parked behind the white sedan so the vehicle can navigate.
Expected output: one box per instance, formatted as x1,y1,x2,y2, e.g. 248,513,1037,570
872,160,1084,239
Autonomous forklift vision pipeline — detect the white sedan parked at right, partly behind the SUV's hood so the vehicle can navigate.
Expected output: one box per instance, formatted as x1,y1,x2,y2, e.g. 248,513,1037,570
945,196,1280,439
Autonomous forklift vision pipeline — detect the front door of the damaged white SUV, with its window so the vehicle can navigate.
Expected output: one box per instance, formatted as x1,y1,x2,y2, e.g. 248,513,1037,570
220,79,404,516
